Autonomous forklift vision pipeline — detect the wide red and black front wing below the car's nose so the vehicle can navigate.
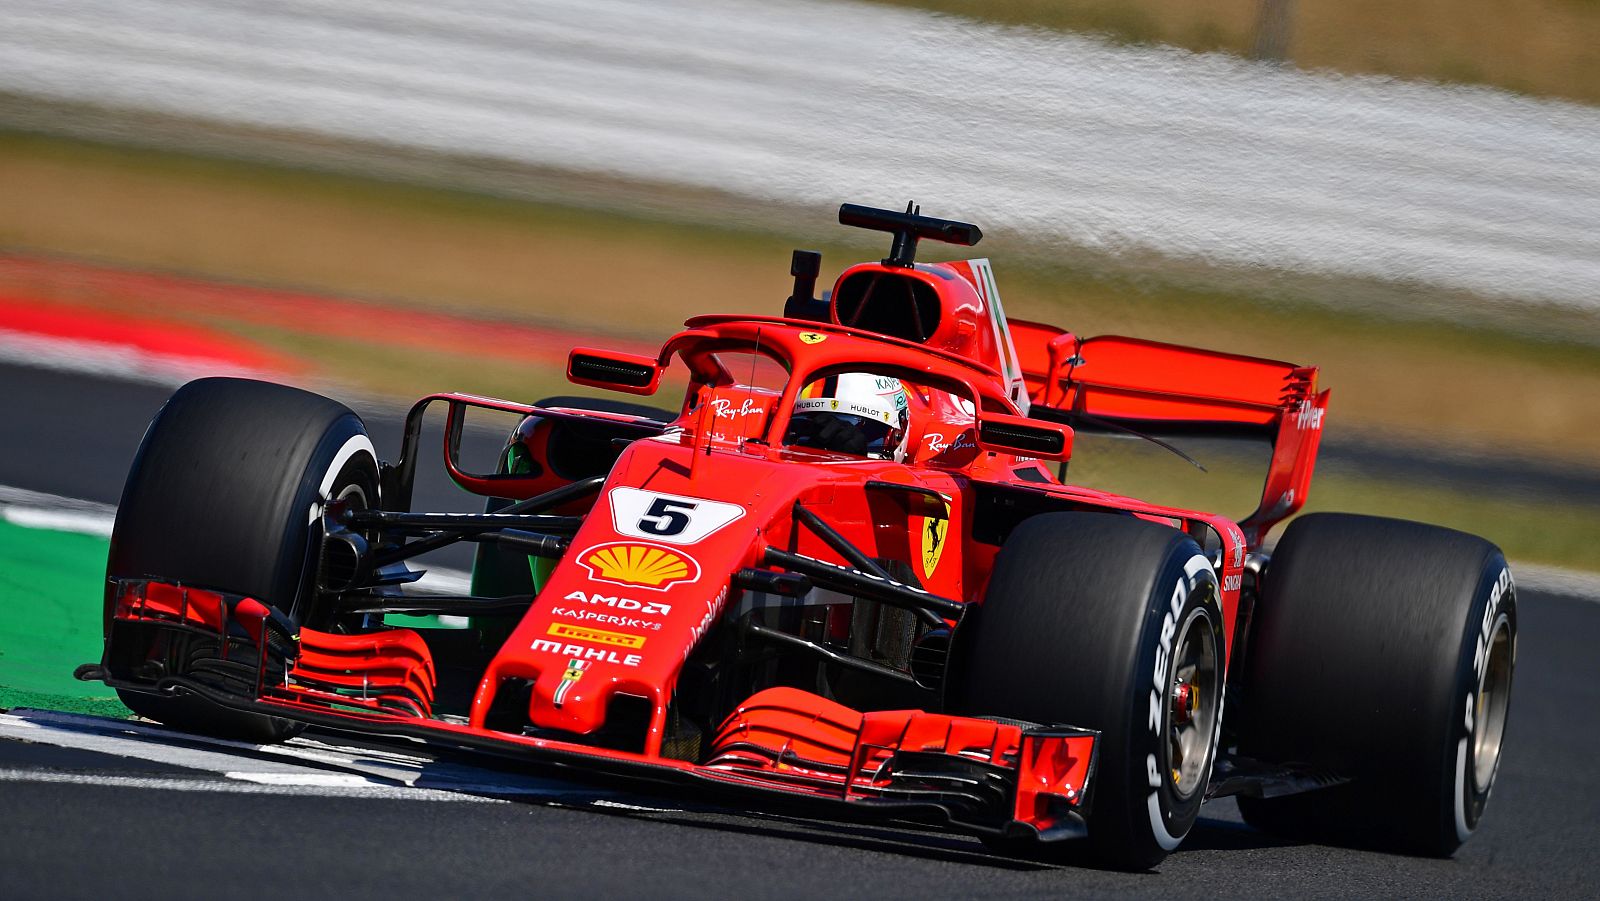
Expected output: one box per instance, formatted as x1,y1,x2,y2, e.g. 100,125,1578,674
78,579,1099,842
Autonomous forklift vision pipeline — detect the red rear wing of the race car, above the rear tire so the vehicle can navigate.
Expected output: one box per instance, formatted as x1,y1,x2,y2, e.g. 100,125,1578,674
1010,320,1328,547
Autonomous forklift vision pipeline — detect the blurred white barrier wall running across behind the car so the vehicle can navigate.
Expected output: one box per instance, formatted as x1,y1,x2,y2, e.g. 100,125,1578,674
0,0,1600,314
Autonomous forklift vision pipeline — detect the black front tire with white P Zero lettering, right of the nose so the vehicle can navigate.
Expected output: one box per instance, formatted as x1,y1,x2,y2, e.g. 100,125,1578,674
949,512,1226,869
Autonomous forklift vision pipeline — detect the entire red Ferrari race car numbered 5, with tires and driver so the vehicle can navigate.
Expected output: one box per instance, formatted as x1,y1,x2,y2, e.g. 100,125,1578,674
80,205,1517,867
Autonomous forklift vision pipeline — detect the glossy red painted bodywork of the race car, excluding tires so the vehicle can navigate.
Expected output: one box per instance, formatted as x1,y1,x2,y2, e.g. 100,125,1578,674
103,252,1326,835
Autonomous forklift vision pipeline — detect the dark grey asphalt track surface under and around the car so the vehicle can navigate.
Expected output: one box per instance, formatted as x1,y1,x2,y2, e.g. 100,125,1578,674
0,366,1600,898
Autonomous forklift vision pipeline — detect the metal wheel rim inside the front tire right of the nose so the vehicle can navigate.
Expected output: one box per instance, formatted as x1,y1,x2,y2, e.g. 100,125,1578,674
1166,607,1221,800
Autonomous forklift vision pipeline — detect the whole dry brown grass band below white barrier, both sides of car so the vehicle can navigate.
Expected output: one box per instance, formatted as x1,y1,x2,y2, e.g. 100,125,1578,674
0,134,1600,466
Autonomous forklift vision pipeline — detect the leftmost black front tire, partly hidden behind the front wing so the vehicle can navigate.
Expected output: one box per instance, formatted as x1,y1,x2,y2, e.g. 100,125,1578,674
104,378,378,743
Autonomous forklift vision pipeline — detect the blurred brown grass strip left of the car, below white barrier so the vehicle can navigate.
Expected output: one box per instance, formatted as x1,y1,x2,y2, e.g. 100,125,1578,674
0,138,789,334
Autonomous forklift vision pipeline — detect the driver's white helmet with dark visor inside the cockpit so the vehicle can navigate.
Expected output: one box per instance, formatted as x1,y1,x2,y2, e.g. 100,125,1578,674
786,373,909,459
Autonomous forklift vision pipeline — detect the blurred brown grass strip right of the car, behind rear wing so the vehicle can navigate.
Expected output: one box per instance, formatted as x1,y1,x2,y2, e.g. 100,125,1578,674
1002,270,1600,466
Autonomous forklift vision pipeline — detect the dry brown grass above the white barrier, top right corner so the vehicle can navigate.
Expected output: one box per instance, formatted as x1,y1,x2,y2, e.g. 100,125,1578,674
880,0,1600,102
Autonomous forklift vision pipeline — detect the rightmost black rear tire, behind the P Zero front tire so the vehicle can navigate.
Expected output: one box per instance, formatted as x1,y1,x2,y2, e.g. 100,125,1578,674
1237,514,1517,856
